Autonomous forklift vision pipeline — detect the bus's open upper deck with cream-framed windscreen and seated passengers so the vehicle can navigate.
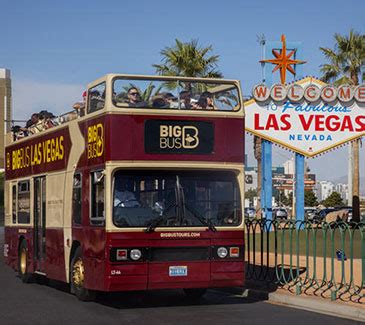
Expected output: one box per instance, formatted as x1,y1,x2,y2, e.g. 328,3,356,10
12,74,243,141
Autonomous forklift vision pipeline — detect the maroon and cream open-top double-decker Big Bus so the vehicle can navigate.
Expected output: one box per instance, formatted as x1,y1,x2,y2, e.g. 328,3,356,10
4,74,244,300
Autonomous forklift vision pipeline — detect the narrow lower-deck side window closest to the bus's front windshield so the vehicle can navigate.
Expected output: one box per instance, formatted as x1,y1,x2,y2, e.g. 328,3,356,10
90,171,105,226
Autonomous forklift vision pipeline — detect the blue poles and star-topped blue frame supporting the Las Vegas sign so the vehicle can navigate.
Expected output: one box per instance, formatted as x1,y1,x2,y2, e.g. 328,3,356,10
261,35,305,220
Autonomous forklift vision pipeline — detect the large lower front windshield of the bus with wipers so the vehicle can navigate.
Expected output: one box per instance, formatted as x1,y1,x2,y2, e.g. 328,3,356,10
113,171,242,227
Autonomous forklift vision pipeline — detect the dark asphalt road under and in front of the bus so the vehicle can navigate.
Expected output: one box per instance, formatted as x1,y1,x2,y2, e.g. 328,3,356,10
0,228,355,325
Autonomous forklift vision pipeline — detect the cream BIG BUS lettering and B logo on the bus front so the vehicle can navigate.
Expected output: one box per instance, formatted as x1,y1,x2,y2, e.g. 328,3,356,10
160,125,199,149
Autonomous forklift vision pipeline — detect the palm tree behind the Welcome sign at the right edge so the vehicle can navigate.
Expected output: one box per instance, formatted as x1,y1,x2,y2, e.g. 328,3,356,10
320,30,365,221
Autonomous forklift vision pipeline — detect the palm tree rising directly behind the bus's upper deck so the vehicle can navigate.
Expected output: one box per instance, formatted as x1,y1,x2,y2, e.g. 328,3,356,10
152,39,223,90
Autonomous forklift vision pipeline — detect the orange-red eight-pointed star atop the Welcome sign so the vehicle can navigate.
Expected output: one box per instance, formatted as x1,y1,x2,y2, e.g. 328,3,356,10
260,35,307,84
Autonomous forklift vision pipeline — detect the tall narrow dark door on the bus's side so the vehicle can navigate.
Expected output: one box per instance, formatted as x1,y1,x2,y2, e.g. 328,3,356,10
34,176,46,272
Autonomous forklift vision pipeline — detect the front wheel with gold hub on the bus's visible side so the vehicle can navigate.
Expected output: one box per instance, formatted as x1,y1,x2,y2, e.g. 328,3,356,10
70,246,96,301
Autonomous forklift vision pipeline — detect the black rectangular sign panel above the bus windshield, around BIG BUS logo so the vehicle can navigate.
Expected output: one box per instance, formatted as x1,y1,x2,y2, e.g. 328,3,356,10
144,120,214,154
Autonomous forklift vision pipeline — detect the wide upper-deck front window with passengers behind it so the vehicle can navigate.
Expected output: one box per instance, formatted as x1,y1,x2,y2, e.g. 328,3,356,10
112,78,240,112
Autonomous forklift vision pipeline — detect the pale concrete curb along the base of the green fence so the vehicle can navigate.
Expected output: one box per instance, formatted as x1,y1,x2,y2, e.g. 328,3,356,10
216,288,365,322
